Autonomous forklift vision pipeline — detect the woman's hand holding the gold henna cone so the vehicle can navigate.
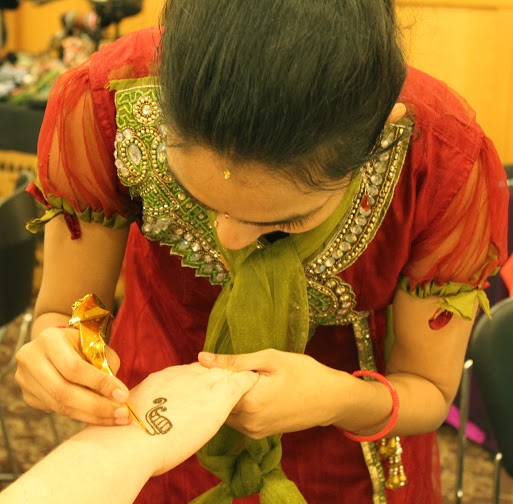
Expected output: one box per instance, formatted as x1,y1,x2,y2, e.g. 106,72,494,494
16,327,130,425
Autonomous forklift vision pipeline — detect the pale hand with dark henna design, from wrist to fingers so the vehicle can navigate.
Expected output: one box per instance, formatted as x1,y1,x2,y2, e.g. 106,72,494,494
124,363,259,476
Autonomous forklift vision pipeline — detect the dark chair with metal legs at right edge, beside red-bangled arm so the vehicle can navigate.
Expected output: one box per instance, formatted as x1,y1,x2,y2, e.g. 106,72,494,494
456,298,513,504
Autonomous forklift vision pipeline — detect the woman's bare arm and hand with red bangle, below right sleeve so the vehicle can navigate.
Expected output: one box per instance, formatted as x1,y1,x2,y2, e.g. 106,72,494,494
195,290,475,438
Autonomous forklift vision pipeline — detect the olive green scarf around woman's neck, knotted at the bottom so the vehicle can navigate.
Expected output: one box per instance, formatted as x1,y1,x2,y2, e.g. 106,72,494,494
192,173,361,504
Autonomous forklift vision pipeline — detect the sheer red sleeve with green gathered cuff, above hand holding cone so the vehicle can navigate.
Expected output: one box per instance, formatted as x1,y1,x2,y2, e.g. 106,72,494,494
30,62,138,227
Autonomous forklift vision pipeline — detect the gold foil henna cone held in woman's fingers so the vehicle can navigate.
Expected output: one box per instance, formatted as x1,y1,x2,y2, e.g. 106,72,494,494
69,294,150,434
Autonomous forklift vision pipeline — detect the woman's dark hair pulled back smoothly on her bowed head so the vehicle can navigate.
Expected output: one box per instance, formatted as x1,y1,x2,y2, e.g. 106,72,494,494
159,0,406,186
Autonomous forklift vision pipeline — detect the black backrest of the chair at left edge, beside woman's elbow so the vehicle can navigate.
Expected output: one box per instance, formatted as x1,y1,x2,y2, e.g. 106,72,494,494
0,172,38,327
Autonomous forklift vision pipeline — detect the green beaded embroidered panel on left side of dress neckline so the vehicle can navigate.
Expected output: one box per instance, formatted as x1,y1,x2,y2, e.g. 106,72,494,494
115,86,228,284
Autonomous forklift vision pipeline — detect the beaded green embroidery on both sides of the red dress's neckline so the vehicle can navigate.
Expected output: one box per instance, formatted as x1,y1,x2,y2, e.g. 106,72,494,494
115,84,410,325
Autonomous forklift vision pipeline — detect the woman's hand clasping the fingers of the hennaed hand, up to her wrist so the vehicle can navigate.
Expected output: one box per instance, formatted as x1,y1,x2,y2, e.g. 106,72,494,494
199,350,351,439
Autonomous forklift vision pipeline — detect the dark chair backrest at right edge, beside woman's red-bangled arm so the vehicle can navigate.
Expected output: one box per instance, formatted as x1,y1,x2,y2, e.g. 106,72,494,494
469,298,513,476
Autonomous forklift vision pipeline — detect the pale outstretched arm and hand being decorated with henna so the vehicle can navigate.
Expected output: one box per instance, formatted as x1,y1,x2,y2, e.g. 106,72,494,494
0,363,258,504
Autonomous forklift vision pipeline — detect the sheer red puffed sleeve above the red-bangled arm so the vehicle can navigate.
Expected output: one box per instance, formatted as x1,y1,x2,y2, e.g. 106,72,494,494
403,135,509,291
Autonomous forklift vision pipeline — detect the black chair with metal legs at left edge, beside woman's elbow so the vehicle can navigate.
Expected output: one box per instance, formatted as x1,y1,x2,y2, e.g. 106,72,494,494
0,172,58,481
